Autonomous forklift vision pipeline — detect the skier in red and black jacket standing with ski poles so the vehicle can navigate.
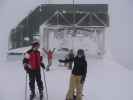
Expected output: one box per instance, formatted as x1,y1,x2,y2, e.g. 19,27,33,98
23,42,45,100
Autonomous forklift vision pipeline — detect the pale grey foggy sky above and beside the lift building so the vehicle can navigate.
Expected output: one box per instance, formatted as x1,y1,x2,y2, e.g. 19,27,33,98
0,0,133,67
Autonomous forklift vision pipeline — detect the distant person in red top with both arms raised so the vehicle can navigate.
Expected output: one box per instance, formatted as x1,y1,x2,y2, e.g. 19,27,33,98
43,48,55,71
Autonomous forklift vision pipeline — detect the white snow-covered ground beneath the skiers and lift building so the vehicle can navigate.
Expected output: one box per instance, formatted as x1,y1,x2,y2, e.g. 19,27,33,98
0,58,133,100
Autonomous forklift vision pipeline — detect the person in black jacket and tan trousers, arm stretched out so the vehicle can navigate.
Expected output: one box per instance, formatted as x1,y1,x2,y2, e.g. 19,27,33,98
64,49,87,100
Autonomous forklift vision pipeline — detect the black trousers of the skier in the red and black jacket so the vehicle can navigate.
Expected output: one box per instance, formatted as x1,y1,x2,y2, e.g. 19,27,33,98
29,69,43,93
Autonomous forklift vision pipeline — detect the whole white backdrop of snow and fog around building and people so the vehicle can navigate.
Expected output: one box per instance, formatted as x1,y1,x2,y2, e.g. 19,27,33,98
0,0,133,100
